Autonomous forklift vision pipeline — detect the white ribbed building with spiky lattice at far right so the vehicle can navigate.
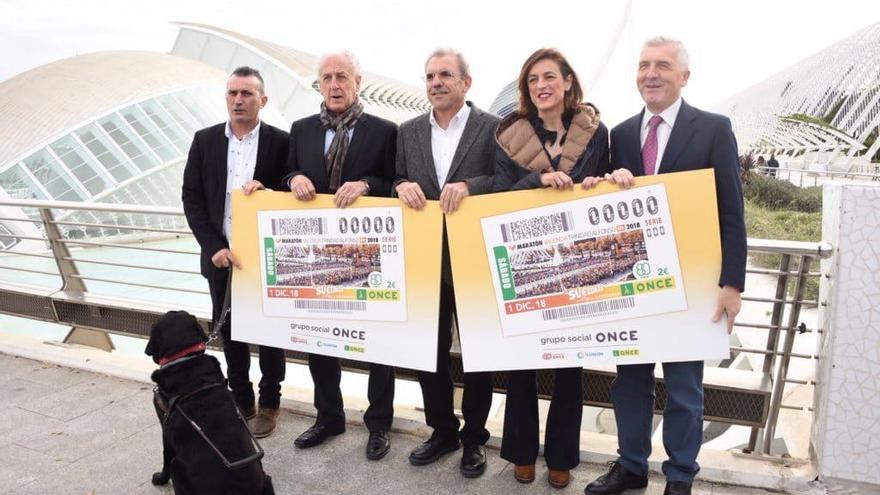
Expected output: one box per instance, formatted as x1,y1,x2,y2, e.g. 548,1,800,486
715,23,880,171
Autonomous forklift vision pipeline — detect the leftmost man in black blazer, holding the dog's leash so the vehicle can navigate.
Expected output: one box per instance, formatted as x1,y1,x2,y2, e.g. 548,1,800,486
183,67,288,437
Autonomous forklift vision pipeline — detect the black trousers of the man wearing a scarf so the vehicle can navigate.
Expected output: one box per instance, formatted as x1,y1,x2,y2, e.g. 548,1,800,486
309,354,394,431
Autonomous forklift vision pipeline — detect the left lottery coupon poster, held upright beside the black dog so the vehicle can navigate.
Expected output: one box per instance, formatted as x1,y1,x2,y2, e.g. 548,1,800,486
231,191,443,371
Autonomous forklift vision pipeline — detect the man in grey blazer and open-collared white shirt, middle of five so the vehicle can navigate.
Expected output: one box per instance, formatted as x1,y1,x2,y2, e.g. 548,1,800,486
394,49,498,478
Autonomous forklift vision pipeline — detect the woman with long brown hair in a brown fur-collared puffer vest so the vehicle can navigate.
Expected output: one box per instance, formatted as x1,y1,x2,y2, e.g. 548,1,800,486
493,48,610,488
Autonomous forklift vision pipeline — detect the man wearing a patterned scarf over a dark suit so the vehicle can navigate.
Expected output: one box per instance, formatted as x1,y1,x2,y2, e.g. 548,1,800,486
285,52,397,460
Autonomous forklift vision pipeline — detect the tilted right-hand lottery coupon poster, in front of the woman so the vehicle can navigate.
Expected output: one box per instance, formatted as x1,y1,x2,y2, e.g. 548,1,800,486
446,169,729,371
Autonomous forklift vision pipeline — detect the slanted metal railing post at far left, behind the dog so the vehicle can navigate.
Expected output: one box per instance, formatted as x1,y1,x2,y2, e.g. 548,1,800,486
40,208,114,352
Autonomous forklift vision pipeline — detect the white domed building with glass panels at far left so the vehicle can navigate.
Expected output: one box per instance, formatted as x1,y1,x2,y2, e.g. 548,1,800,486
0,52,234,237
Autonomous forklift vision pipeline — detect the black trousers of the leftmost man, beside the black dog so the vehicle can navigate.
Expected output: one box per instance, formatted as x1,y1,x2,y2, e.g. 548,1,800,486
208,268,285,409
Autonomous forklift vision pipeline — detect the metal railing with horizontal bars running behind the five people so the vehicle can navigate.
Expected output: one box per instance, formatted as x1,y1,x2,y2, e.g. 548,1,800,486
0,200,832,454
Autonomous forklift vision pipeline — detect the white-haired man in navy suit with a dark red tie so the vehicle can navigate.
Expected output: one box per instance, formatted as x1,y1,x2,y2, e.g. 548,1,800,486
584,37,746,495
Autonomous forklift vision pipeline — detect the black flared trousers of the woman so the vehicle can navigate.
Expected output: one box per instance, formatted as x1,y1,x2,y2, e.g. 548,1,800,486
501,368,584,470
